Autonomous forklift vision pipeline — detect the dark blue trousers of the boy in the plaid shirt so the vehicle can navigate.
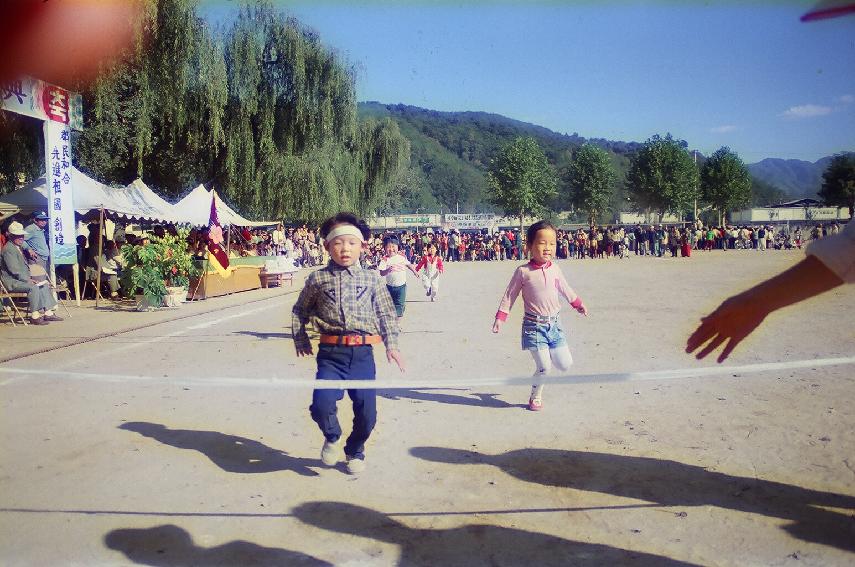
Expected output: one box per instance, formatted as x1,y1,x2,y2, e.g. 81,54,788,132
309,344,377,457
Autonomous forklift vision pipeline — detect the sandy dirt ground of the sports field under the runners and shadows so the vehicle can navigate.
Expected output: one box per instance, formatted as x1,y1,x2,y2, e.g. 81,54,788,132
0,251,855,566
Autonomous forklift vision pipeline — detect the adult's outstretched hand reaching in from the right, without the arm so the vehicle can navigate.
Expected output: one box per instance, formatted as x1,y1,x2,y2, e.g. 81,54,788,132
686,290,770,362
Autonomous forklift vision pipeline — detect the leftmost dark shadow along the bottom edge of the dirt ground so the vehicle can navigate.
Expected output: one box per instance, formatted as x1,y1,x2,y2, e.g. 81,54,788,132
104,524,332,567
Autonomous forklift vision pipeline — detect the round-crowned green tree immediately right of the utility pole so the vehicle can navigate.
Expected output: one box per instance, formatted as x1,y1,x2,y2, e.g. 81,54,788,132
701,146,751,226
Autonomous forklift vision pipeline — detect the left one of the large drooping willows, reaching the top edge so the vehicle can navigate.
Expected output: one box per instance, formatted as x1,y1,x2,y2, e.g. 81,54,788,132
73,0,227,195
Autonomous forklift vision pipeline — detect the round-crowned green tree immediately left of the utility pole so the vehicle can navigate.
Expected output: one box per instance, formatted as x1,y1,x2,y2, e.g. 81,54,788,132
626,134,698,222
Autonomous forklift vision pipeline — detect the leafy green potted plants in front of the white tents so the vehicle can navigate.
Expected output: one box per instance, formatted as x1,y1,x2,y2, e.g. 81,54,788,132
122,229,199,306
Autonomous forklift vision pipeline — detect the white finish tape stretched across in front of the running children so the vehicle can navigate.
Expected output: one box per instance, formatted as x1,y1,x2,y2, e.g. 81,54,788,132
0,356,855,390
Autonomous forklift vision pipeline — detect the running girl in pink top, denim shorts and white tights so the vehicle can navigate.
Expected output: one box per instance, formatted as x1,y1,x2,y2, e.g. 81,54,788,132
493,221,588,411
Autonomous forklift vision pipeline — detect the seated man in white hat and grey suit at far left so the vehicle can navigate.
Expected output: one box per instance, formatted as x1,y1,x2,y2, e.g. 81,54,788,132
0,222,62,325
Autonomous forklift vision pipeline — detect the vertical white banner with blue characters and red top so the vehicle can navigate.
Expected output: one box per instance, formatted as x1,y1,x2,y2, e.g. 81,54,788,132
41,85,77,266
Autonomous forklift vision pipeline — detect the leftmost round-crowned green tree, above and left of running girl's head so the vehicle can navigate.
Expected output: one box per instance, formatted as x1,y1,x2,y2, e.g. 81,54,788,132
487,137,557,242
